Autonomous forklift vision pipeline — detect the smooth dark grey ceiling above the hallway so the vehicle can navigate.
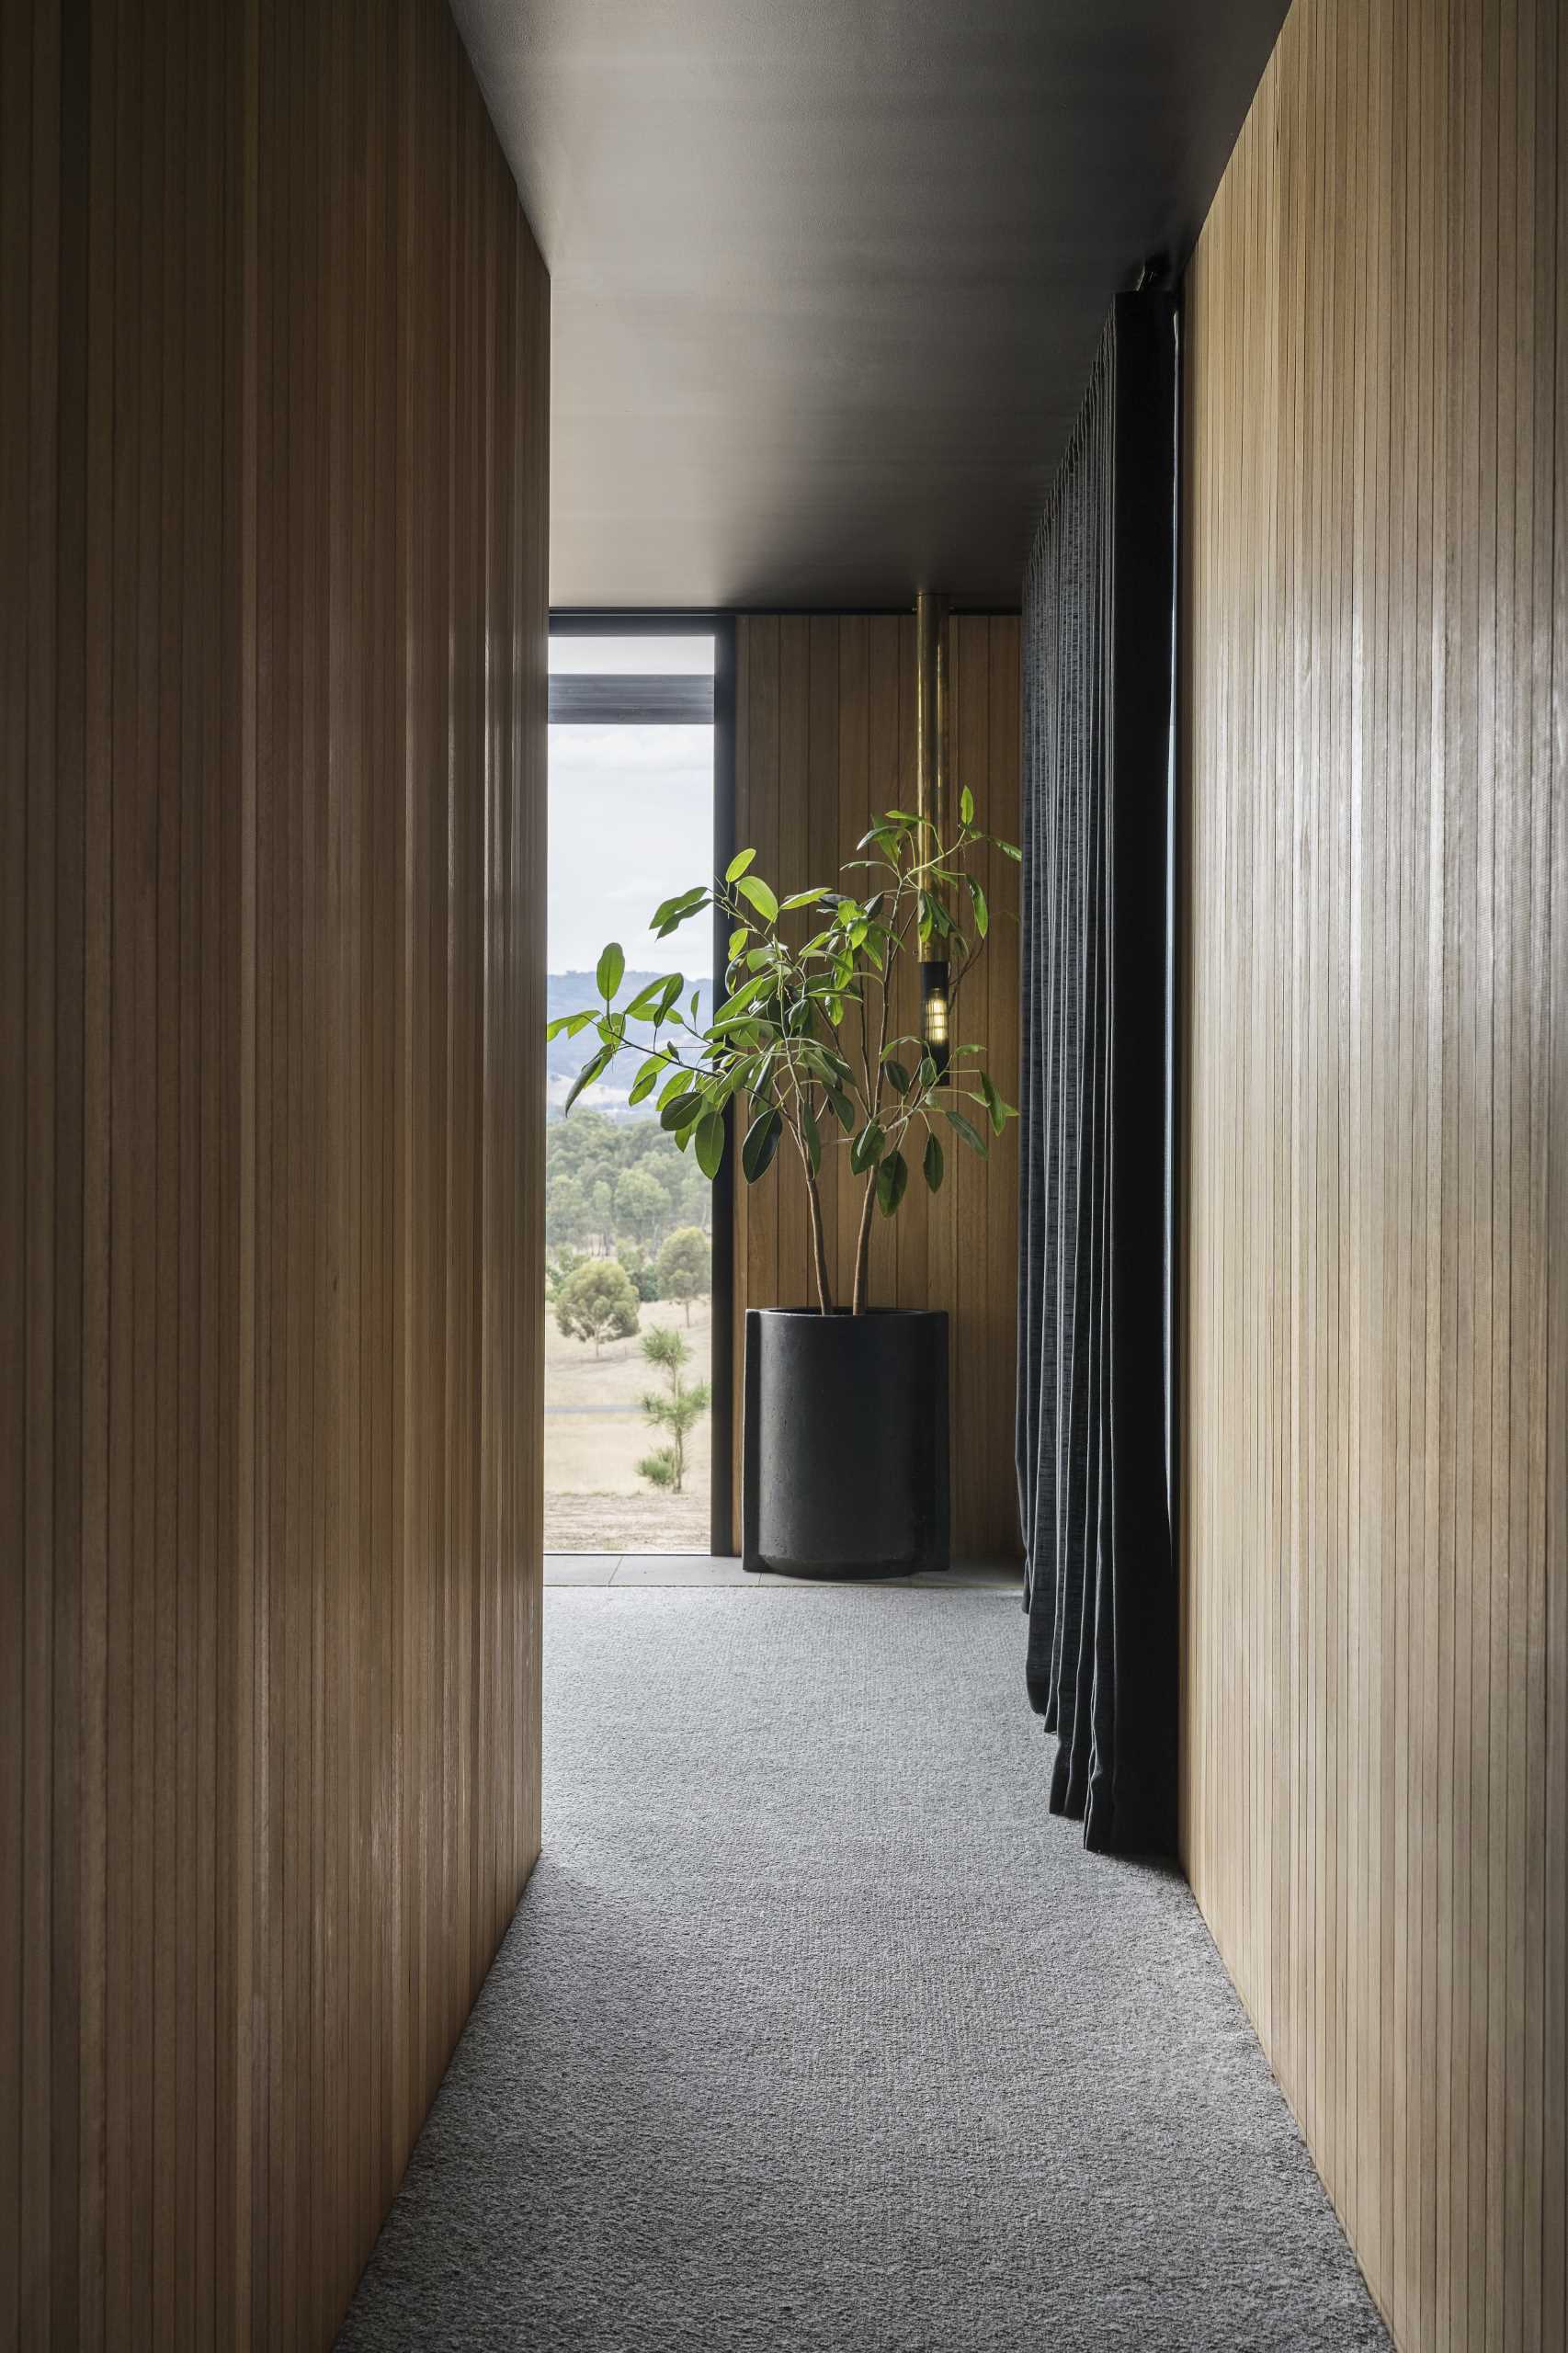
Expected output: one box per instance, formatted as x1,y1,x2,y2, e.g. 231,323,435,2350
454,0,1283,607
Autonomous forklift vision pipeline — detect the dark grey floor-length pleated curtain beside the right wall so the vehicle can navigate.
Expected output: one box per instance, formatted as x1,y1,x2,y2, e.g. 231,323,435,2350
1017,294,1177,1852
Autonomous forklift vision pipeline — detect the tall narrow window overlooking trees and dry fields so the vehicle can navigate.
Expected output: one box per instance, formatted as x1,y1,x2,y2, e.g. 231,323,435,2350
544,623,713,1553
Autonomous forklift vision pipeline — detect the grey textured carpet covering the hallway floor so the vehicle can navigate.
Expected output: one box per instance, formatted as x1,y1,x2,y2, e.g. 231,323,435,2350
341,1586,1387,2353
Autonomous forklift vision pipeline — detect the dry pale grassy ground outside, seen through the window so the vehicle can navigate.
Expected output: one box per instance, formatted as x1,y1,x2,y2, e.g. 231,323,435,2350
544,1299,711,1553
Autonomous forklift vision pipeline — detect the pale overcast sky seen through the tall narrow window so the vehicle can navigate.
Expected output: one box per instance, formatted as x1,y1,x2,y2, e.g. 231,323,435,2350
549,638,713,979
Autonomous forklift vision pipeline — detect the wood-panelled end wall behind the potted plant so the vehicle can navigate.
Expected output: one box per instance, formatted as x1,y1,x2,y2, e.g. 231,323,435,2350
734,614,1022,1558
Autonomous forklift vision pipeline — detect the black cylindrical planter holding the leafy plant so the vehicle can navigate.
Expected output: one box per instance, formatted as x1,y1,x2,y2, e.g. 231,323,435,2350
742,1308,949,1576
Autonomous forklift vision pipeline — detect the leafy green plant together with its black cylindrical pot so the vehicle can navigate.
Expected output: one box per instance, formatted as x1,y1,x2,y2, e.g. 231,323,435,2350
549,790,1017,1576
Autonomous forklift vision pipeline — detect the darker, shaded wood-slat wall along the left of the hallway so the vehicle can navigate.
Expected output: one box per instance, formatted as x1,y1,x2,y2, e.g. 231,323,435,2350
0,0,549,2348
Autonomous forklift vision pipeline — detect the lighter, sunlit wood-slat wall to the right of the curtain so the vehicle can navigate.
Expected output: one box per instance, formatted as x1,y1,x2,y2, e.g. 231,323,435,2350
1182,0,1568,2353
